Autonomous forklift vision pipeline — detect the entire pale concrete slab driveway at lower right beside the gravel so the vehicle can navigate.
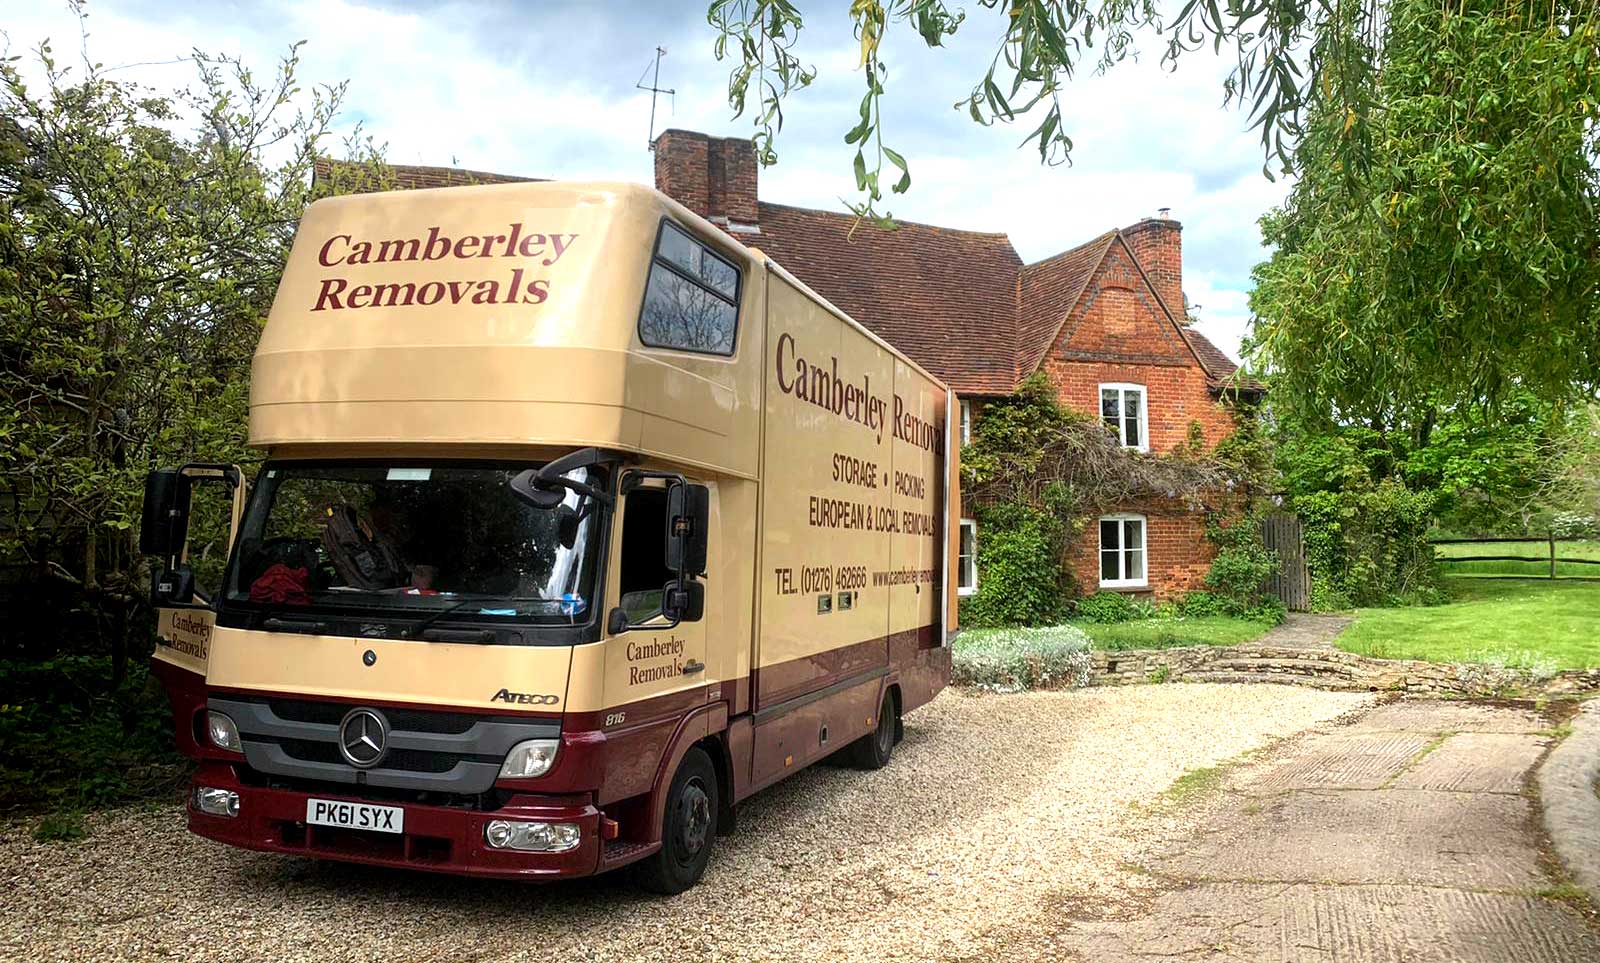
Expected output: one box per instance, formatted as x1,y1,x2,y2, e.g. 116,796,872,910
1061,701,1600,963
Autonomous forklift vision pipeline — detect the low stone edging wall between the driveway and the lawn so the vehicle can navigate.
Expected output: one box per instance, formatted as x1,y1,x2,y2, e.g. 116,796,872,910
1088,643,1600,696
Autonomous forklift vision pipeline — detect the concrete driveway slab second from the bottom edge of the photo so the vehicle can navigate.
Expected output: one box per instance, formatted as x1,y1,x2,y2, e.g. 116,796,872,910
1149,790,1546,891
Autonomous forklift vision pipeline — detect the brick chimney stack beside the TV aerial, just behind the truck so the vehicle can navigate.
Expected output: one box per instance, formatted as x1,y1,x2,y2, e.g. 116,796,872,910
656,130,760,234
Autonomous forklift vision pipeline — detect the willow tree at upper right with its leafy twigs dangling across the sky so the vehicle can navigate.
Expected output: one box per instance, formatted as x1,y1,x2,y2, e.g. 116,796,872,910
707,0,1600,409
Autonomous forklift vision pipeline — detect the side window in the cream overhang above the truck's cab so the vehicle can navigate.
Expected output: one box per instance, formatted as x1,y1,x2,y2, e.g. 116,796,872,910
638,221,739,355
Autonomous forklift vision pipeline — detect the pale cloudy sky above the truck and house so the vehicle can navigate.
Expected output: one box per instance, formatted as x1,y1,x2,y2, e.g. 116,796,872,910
0,0,1286,358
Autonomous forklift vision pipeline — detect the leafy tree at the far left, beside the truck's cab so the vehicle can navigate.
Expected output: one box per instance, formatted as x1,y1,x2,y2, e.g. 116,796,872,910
0,37,366,680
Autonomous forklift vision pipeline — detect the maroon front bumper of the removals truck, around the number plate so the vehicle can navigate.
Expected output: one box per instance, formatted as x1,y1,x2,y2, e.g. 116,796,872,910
189,763,600,880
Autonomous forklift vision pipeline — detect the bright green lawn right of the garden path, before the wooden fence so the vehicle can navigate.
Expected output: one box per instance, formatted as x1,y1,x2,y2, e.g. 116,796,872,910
1336,576,1600,669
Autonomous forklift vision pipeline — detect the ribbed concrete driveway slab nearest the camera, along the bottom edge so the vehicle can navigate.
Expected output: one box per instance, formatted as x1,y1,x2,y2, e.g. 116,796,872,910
1066,883,1600,963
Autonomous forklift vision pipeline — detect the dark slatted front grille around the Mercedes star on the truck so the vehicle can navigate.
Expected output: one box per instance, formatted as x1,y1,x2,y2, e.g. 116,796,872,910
208,697,562,797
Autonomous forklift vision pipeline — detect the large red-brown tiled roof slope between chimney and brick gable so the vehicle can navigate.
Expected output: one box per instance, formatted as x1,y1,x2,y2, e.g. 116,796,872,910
752,202,1022,394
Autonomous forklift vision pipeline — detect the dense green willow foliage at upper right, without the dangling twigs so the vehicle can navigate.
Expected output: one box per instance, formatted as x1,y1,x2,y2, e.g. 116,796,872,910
1251,0,1600,419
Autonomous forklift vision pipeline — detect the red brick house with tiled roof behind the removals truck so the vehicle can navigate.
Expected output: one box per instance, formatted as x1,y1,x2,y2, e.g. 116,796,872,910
317,130,1261,598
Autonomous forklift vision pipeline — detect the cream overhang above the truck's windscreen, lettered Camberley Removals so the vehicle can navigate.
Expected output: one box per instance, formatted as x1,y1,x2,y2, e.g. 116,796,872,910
250,184,760,477
